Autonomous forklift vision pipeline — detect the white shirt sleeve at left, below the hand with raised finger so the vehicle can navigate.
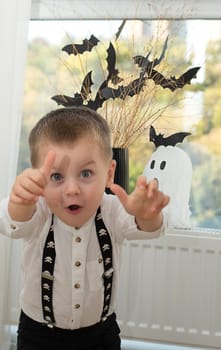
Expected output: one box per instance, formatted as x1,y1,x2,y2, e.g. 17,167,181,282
0,197,48,239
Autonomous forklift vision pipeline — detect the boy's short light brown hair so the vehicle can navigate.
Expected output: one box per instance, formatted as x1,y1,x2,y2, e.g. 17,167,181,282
29,107,112,166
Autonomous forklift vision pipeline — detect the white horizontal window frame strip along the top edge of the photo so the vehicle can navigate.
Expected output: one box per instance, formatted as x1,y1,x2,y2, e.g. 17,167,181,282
31,0,221,20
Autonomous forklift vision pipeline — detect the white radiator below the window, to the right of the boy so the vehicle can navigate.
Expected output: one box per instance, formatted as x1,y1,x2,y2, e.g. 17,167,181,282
117,230,221,349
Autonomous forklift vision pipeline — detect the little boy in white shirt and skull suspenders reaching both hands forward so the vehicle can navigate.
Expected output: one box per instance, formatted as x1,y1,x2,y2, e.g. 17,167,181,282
0,107,169,350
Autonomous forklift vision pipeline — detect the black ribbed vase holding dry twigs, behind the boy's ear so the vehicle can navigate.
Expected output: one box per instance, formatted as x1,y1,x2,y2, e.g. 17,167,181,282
106,147,129,193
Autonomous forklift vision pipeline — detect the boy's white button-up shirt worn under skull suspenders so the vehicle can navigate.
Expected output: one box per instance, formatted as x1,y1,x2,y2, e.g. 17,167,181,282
0,194,166,329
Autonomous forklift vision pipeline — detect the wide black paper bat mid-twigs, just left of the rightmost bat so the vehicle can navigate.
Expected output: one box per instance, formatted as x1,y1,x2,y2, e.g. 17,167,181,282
101,77,146,100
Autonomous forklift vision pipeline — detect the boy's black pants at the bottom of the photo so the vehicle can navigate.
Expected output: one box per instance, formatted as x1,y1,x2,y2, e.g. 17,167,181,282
17,312,121,350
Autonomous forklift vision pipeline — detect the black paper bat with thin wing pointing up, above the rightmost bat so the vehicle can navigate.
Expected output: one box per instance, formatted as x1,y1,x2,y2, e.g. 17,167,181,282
133,36,168,74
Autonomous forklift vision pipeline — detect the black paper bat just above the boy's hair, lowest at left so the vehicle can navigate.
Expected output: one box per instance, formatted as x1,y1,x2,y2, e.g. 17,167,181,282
52,71,93,107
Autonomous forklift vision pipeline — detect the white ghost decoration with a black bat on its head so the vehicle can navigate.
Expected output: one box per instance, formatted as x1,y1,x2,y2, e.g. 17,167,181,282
144,127,192,228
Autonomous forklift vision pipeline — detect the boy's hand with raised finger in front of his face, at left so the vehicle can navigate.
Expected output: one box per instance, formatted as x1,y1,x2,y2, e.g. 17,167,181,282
9,151,56,221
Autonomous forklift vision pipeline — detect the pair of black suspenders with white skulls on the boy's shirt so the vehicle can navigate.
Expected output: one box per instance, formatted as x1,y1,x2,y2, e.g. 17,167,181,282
41,208,114,327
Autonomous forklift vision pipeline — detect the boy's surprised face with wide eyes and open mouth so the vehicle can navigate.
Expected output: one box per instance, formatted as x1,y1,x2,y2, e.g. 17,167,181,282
38,136,115,228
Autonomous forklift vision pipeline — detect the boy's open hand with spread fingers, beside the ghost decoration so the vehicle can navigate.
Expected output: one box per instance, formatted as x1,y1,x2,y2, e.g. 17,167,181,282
111,175,169,231
